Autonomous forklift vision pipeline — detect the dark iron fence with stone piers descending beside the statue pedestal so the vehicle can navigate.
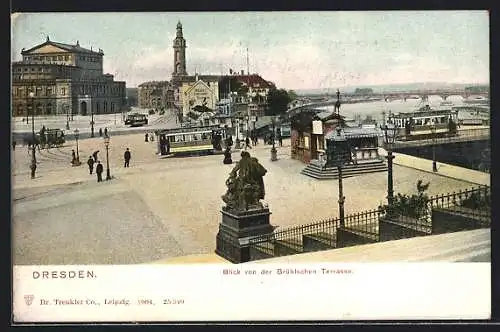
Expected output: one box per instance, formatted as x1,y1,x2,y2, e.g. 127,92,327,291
248,186,491,260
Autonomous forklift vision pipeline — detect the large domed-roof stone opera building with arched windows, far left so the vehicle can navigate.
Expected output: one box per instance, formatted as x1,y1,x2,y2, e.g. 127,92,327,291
12,37,127,116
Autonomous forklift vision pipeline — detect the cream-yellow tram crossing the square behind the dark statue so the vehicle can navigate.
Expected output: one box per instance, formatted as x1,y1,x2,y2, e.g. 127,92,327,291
155,126,226,156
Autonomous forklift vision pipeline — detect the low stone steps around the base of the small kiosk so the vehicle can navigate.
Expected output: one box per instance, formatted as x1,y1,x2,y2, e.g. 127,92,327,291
300,160,387,180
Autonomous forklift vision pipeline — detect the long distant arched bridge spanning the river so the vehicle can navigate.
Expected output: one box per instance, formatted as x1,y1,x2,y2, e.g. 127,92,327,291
288,89,490,111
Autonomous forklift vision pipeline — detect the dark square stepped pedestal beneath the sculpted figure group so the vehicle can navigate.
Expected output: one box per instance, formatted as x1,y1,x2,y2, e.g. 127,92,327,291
215,208,274,263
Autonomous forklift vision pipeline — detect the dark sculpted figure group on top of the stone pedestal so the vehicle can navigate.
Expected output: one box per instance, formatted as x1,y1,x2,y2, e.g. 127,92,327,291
222,151,267,211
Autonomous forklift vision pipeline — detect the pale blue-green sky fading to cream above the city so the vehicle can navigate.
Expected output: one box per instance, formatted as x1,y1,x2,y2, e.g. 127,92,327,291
11,11,489,90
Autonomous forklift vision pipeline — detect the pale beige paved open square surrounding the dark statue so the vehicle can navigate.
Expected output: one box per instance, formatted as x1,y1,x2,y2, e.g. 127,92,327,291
12,134,489,264
